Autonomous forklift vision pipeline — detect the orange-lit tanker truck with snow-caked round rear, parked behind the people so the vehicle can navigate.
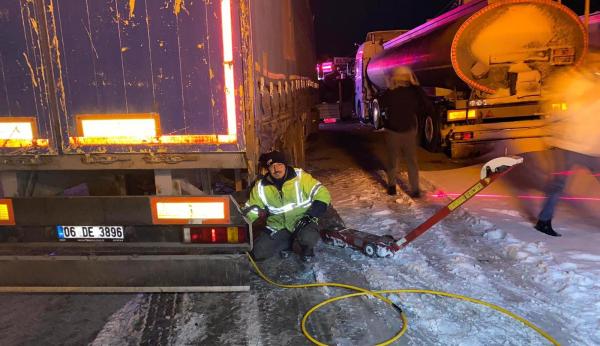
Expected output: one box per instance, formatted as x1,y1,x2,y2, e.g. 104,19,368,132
355,0,588,158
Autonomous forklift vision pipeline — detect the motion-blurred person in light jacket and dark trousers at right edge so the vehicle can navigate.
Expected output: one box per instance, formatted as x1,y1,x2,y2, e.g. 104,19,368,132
535,53,600,237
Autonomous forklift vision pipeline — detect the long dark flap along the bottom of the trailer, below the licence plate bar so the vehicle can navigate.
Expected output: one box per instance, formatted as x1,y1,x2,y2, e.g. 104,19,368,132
0,254,250,293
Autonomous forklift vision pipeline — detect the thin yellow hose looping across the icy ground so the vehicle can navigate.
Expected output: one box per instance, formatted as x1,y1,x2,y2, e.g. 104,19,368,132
246,253,560,346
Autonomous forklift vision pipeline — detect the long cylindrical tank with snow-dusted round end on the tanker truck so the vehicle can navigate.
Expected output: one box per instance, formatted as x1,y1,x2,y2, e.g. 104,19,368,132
367,0,588,97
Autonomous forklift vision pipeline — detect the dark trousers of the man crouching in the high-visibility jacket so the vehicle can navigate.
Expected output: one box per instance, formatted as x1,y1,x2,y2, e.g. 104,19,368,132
252,223,321,260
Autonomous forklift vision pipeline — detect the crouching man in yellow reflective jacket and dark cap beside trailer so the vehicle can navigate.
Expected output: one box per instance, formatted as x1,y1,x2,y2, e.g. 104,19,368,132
246,151,331,262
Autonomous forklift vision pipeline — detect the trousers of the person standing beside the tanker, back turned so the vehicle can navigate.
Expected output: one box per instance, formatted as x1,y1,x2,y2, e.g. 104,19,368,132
385,130,419,193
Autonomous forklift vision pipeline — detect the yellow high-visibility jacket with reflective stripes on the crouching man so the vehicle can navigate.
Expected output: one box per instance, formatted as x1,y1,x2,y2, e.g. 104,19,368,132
246,166,331,232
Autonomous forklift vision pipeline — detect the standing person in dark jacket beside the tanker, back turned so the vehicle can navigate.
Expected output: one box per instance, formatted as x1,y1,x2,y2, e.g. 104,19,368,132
379,67,435,198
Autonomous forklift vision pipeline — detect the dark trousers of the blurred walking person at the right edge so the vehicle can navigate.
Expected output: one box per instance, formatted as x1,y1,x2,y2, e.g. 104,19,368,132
538,148,600,221
